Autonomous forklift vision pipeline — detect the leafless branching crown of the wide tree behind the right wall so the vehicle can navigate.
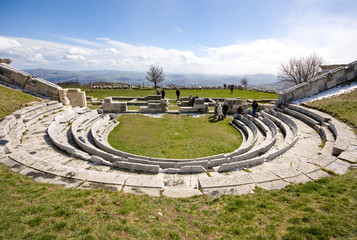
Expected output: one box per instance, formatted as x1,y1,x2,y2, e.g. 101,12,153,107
278,53,323,85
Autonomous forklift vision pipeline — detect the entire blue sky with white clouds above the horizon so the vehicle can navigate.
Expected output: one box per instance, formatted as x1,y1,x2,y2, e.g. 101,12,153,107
0,0,357,74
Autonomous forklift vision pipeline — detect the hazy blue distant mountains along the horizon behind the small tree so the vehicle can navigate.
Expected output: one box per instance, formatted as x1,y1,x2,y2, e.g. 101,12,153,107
23,68,284,89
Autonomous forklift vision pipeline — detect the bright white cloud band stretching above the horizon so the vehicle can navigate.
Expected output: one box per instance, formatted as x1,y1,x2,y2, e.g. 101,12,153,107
0,9,357,74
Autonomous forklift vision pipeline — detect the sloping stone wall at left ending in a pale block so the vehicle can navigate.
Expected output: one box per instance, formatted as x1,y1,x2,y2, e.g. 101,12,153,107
0,61,87,107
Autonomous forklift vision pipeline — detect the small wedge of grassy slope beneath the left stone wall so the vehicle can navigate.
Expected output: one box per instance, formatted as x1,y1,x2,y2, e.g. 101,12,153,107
0,86,40,119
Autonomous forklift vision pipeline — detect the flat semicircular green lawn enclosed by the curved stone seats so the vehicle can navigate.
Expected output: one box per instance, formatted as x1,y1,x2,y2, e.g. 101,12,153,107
108,114,242,158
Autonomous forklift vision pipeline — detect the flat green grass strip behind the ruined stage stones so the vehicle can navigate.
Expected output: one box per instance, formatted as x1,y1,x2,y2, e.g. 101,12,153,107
73,86,278,100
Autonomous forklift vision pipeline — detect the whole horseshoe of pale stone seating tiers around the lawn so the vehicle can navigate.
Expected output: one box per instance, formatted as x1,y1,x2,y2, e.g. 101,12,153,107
0,104,357,197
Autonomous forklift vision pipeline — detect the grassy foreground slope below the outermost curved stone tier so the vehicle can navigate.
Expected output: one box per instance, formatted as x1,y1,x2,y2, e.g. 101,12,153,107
0,86,357,240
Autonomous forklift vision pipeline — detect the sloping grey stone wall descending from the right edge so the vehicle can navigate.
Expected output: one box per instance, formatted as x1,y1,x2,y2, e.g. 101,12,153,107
276,61,357,106
